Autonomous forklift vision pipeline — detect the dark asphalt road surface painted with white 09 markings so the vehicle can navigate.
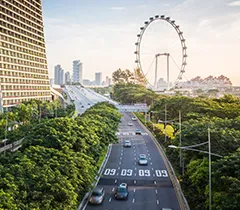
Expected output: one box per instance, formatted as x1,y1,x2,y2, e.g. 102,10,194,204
85,113,180,210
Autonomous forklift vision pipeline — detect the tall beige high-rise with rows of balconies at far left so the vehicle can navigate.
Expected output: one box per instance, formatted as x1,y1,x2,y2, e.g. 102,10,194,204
0,0,51,111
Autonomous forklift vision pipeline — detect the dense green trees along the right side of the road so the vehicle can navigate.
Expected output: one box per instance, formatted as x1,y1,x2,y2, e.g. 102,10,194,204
113,83,240,210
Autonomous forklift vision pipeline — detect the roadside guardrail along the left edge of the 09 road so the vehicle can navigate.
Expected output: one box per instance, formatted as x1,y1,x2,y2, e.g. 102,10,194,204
77,144,112,210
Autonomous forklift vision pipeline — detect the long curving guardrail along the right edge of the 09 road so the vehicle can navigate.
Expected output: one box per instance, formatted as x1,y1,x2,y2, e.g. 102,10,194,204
135,115,190,210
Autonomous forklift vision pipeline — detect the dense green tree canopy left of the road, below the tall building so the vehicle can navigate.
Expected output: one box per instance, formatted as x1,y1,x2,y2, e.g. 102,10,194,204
0,101,121,210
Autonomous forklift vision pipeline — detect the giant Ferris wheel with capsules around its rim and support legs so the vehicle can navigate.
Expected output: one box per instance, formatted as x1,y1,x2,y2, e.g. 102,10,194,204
134,15,187,90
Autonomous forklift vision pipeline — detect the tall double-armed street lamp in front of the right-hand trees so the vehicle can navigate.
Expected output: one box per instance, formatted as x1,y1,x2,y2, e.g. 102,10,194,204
168,128,223,210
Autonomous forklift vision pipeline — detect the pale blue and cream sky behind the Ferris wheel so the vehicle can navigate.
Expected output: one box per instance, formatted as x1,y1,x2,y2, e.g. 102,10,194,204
42,0,240,85
